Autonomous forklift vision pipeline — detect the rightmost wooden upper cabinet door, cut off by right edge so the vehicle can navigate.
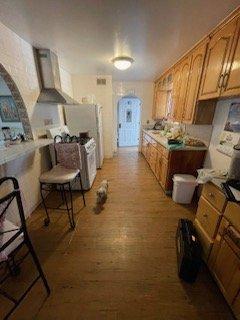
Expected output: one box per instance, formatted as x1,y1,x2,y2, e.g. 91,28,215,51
221,19,240,97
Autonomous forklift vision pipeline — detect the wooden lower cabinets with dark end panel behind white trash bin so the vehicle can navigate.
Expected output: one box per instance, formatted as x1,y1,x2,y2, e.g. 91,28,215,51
141,132,205,193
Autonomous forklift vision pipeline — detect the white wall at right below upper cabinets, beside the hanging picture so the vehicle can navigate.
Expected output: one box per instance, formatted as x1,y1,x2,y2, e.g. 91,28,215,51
204,98,240,170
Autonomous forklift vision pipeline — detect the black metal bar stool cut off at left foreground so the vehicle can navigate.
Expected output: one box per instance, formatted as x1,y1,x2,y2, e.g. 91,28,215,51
0,177,50,319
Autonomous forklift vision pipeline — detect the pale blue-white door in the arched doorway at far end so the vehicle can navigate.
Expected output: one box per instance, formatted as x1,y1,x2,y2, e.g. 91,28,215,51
118,96,142,147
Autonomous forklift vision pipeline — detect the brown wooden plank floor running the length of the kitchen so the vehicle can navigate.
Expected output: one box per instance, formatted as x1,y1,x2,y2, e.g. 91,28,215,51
0,148,233,320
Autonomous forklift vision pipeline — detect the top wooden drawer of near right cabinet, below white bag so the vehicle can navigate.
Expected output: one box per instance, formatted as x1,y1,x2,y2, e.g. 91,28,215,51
202,183,226,212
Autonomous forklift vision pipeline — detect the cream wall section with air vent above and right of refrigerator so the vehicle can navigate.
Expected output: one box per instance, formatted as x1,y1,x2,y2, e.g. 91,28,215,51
72,75,113,158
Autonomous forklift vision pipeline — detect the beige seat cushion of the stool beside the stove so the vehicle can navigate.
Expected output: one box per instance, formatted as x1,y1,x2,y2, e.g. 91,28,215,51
39,164,79,184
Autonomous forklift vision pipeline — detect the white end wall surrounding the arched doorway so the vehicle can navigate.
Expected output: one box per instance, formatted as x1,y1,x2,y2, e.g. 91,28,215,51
113,81,154,151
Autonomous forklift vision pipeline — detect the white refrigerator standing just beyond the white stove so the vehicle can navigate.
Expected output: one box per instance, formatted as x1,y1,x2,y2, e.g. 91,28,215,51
64,104,103,169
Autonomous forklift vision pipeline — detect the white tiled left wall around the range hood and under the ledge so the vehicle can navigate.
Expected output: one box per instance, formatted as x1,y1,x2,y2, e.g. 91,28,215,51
0,23,71,220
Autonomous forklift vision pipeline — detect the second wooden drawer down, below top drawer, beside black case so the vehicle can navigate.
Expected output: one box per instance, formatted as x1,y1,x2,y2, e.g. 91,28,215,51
196,197,221,238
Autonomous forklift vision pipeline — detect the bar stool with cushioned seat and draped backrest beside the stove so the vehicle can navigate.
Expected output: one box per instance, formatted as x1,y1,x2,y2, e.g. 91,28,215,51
39,137,86,229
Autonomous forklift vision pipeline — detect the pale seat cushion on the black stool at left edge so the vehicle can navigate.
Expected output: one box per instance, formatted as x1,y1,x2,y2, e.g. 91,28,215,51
0,219,24,262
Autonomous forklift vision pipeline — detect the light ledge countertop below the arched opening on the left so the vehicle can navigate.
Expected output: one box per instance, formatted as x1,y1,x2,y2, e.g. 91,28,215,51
0,139,53,165
